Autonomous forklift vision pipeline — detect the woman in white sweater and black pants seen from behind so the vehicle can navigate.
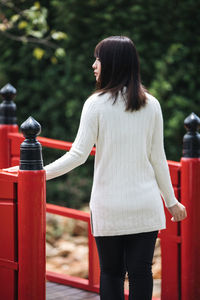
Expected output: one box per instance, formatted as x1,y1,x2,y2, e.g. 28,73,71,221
7,36,186,300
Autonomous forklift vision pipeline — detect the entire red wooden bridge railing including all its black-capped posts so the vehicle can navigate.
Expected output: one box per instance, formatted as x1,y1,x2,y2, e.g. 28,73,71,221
0,85,200,300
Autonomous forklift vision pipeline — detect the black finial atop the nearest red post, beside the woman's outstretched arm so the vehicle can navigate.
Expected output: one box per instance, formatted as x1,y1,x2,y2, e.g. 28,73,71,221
20,117,43,170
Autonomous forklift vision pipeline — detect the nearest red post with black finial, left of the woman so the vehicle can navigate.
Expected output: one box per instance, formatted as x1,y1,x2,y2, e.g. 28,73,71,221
18,118,46,300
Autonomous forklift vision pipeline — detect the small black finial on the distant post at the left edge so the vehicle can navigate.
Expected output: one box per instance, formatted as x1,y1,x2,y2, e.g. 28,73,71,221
0,83,17,125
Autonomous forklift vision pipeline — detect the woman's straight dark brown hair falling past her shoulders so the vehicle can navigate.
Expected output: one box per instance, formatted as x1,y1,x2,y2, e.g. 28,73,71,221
94,36,147,111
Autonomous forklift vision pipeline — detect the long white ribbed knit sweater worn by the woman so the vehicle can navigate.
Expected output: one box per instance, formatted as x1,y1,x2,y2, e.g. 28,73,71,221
45,93,178,236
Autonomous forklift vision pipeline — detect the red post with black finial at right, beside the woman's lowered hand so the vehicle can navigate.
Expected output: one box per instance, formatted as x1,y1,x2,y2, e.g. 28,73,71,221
181,114,200,300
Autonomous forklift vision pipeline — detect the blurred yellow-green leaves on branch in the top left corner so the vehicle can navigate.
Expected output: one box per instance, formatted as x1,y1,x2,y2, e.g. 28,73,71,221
0,0,67,63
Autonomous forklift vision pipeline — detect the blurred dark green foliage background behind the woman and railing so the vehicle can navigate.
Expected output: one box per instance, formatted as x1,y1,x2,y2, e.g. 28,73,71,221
0,0,200,208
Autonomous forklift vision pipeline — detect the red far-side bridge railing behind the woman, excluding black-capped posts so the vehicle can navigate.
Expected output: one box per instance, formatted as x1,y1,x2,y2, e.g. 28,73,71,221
8,132,181,300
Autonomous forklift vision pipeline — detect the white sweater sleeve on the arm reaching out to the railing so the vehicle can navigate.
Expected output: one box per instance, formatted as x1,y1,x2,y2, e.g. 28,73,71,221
44,97,98,180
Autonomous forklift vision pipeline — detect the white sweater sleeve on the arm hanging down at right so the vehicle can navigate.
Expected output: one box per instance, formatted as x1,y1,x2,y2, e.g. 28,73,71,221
150,100,178,207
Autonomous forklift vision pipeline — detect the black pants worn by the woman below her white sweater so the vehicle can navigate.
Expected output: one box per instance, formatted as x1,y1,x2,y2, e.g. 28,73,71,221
95,231,158,300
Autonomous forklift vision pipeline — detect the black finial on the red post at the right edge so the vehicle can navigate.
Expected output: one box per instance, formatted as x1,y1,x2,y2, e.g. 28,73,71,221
183,113,200,158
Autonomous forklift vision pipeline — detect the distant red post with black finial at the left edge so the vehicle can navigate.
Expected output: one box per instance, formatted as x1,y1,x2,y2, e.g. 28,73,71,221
0,84,18,168
